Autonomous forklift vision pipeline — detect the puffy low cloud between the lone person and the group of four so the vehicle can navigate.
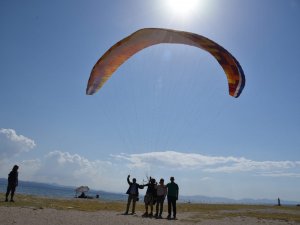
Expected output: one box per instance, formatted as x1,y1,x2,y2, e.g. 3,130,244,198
32,151,124,191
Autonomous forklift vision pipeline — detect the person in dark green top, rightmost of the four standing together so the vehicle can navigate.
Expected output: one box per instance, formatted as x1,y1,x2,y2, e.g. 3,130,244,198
167,177,179,219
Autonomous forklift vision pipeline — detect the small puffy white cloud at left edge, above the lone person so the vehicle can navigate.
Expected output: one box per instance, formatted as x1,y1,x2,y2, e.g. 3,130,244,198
0,128,36,158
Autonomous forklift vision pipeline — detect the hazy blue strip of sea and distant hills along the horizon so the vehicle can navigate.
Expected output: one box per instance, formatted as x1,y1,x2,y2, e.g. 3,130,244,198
0,178,300,205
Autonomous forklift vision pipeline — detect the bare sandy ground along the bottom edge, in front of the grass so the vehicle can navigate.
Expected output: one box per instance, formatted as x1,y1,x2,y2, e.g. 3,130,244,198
0,206,299,225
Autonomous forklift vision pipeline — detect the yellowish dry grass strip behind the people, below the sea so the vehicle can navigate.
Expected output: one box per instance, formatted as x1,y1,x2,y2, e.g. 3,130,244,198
0,194,300,222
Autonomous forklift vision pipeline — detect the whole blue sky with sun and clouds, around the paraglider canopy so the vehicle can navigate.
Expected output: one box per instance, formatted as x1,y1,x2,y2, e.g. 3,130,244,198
0,0,300,201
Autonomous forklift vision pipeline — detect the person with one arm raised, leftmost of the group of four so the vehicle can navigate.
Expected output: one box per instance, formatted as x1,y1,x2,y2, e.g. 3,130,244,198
124,175,144,215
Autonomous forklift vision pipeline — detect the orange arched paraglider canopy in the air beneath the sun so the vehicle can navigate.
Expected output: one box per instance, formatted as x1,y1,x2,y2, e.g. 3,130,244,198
86,28,245,98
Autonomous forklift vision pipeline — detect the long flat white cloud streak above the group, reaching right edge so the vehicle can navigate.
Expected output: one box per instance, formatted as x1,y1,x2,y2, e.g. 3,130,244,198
113,151,300,175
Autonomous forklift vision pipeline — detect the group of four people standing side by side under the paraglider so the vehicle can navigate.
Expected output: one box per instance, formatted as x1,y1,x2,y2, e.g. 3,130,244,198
124,175,179,219
